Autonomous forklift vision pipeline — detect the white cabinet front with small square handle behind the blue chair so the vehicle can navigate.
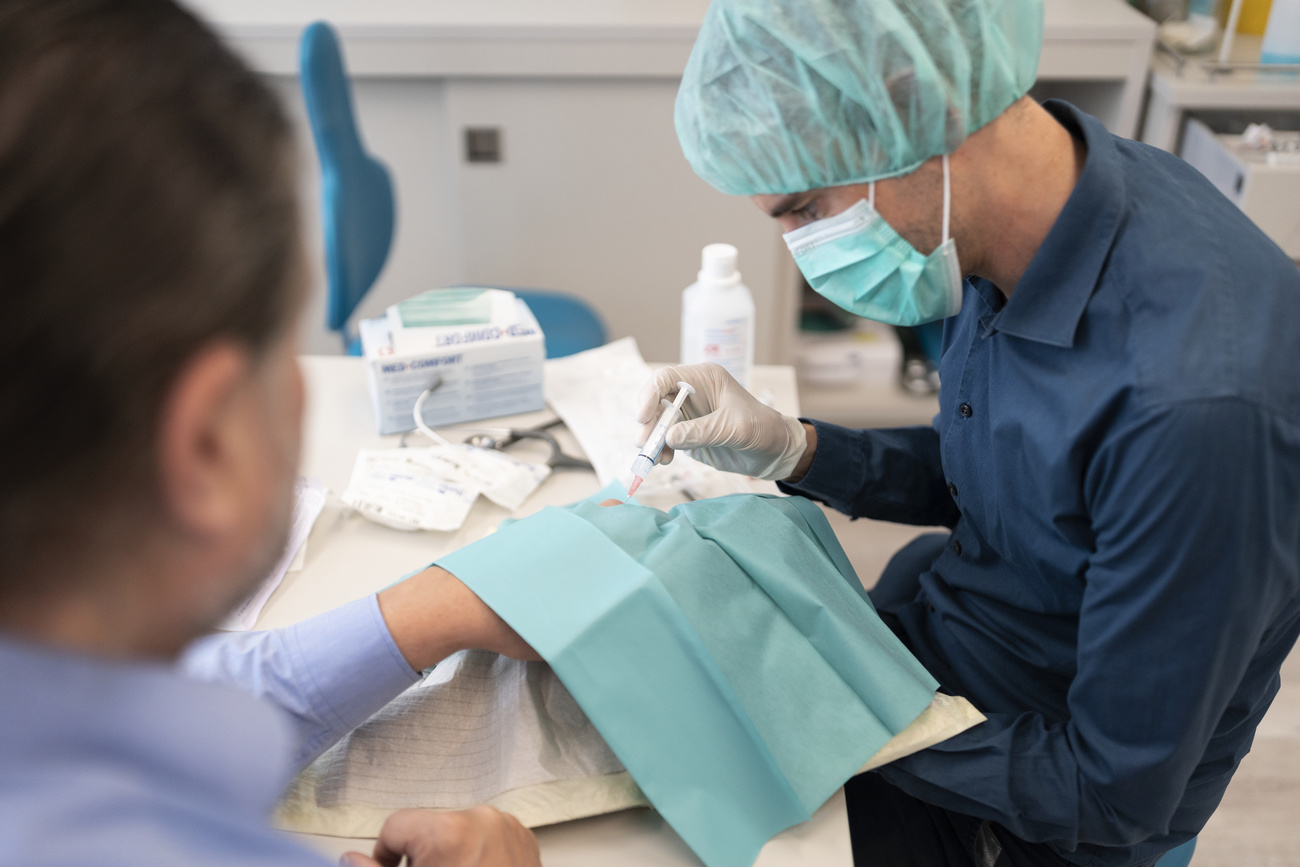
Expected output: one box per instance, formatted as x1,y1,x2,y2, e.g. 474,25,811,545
273,77,793,361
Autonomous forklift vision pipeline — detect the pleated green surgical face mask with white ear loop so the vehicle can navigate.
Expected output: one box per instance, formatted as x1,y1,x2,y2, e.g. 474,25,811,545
785,155,962,325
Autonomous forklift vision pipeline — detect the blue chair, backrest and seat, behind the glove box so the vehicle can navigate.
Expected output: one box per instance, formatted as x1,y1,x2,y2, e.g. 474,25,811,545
299,21,605,359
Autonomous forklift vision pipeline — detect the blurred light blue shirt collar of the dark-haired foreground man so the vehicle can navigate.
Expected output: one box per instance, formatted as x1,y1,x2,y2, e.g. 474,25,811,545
0,633,294,820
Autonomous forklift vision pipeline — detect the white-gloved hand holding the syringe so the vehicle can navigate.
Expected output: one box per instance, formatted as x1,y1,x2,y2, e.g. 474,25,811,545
637,361,807,480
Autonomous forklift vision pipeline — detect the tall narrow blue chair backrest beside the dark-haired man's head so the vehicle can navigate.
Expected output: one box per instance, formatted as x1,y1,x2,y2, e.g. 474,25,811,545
299,21,397,344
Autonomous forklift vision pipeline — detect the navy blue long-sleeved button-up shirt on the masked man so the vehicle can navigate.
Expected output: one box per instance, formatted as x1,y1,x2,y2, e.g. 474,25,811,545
785,103,1300,867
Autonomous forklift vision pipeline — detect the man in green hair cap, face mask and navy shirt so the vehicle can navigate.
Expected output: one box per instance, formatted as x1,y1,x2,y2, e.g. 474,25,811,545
640,0,1300,867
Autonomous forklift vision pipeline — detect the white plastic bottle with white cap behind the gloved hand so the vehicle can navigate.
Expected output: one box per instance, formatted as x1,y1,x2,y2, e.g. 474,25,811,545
681,244,754,389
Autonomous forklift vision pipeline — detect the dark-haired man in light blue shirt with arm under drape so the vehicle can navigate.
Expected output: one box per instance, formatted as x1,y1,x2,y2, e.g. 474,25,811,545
0,0,540,867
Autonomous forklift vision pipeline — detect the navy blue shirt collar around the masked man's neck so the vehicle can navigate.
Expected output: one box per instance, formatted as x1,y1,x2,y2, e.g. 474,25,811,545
976,100,1126,346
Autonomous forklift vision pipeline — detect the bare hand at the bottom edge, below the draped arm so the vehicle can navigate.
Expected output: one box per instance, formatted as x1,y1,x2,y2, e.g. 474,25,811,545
339,807,542,867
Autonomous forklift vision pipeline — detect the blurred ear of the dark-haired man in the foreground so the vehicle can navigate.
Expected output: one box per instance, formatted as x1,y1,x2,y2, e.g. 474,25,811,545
157,342,252,536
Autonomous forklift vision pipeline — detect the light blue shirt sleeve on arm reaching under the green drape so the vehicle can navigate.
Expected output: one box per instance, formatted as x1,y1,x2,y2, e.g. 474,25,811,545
181,595,419,768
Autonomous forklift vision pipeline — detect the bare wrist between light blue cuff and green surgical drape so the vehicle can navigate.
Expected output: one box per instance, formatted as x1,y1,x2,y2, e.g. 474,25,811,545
380,565,541,671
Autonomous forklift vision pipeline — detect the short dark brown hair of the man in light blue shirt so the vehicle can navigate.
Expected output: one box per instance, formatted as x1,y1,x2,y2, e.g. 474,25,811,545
0,0,300,582
